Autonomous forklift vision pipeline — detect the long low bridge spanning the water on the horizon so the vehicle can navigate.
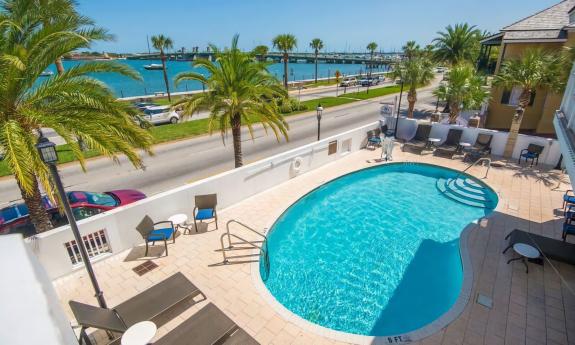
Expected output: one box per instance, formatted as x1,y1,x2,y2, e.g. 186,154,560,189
127,52,403,67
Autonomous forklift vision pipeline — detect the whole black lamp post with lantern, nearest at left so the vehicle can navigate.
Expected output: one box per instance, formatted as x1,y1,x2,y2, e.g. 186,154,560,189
36,136,108,308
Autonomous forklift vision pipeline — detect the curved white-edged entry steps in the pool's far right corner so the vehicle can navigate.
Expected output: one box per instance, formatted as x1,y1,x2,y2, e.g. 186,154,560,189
436,176,497,208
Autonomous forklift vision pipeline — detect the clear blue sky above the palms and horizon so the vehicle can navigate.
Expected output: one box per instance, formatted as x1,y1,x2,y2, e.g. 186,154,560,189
80,0,559,52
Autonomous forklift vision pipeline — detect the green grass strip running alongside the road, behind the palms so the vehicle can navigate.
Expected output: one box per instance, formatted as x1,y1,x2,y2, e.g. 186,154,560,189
0,81,414,176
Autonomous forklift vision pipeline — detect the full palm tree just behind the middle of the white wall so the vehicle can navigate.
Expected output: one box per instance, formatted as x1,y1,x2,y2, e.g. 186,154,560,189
174,35,288,168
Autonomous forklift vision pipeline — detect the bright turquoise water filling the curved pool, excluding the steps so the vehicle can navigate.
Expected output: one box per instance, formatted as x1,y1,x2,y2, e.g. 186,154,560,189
260,164,497,336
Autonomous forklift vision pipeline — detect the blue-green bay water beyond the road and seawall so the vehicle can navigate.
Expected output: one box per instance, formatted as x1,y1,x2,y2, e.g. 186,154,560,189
44,60,387,97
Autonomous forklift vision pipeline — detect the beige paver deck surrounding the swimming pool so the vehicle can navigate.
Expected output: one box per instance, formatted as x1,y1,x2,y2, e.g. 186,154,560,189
54,148,575,345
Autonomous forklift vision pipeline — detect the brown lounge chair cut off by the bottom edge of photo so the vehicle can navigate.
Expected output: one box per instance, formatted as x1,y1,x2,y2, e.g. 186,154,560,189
154,303,259,345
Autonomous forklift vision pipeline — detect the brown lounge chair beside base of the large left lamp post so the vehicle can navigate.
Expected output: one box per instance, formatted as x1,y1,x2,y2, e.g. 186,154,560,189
69,272,202,344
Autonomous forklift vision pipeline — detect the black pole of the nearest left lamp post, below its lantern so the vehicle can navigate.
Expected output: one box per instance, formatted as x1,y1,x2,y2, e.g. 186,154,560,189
48,164,108,308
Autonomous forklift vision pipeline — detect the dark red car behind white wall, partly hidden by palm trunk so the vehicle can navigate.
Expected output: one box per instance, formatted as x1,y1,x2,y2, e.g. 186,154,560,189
0,189,146,237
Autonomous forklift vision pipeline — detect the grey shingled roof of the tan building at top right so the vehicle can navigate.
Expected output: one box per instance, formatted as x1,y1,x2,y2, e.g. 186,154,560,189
490,0,575,44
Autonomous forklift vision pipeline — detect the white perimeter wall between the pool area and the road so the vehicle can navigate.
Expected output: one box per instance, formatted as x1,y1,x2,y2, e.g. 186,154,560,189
28,118,561,279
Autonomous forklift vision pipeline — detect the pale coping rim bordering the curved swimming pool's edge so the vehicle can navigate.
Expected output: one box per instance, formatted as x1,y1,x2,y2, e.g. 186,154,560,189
250,161,501,344
